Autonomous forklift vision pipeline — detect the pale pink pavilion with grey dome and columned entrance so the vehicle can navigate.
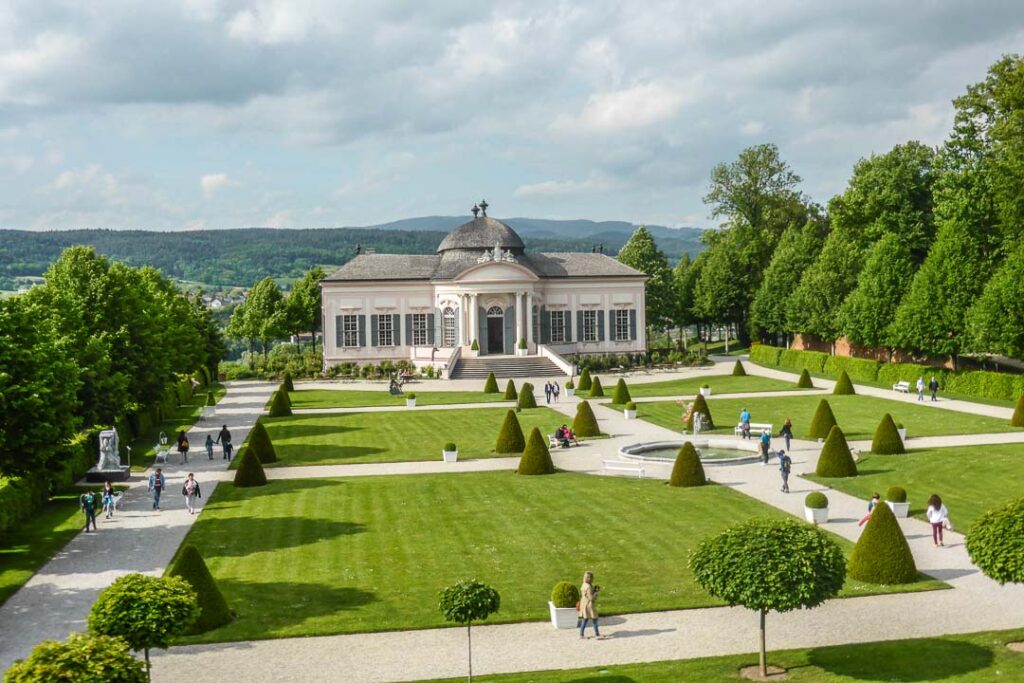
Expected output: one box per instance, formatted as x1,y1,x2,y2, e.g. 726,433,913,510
321,202,647,378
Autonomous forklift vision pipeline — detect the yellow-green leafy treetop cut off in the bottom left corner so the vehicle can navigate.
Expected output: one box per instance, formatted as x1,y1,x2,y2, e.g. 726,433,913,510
3,633,147,683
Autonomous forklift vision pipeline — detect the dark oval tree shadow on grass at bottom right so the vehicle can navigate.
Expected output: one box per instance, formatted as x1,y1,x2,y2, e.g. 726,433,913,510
809,638,993,683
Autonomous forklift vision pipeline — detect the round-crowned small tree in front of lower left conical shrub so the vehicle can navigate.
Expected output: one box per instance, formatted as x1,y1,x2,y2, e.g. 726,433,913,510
89,573,199,677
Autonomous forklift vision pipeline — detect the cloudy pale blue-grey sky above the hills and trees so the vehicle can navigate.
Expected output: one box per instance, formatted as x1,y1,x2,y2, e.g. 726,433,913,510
0,0,1024,230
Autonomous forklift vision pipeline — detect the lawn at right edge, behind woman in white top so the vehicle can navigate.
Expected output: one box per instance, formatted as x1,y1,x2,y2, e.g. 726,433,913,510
810,443,1024,531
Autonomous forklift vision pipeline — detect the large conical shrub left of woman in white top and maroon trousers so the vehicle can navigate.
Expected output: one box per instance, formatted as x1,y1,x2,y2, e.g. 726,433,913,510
846,503,918,586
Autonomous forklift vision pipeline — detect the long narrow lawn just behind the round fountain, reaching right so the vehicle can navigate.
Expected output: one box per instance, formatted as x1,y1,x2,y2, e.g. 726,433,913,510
637,394,1017,439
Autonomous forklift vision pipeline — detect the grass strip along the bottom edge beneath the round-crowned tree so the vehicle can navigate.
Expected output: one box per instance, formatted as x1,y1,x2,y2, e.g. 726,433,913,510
419,634,1024,683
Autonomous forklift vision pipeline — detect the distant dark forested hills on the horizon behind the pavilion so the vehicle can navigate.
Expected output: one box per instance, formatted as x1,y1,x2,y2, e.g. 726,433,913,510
0,217,703,290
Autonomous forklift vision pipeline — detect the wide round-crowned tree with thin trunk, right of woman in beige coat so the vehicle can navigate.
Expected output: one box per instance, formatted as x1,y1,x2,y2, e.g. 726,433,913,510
690,519,846,677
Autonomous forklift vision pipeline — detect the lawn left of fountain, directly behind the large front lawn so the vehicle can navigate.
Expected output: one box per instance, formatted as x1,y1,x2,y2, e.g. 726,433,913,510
252,408,570,467
